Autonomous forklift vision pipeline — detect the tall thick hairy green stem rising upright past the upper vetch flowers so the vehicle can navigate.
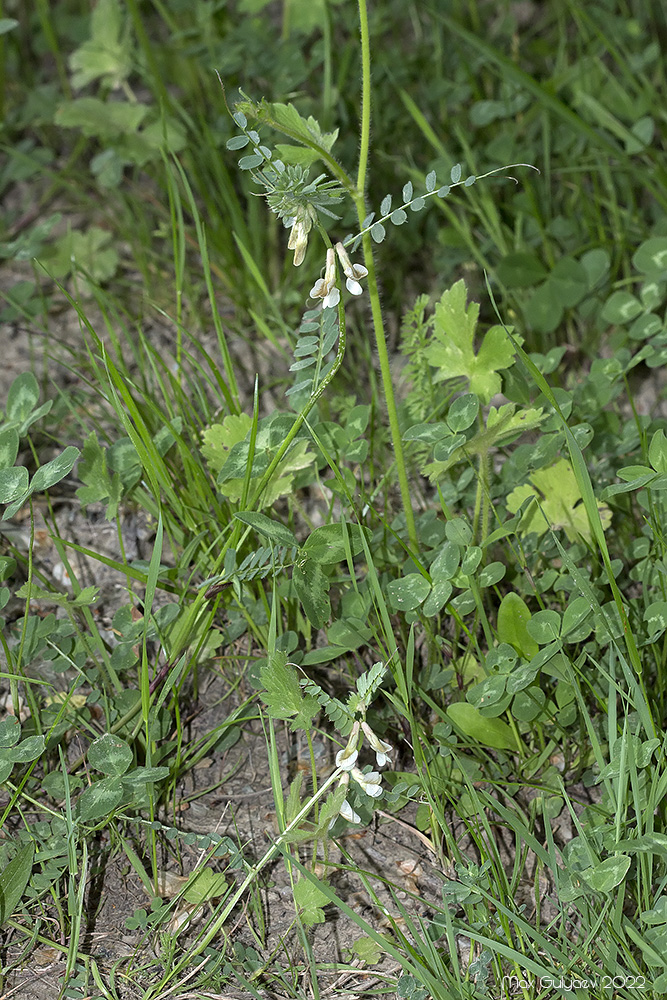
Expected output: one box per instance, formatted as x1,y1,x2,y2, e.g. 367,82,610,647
354,0,418,552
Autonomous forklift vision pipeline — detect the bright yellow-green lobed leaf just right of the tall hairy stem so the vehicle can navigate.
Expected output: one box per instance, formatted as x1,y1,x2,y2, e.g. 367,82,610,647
424,280,514,403
